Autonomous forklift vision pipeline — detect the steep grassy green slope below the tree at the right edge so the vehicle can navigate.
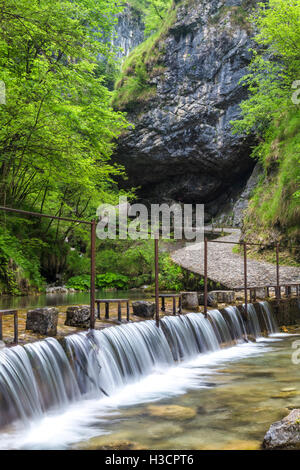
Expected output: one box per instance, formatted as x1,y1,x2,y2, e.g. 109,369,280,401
245,111,300,242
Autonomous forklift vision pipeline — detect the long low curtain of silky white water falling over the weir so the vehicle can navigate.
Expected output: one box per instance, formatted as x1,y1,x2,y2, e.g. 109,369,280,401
0,302,277,427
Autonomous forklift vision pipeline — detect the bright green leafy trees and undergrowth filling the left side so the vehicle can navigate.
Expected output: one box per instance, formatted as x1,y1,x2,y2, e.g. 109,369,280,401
0,0,135,292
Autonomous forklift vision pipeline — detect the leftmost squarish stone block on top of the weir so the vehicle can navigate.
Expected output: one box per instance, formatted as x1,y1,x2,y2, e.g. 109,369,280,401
26,307,58,336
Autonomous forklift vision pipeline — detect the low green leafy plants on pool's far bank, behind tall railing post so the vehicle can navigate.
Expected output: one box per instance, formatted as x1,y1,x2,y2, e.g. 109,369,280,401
67,272,128,290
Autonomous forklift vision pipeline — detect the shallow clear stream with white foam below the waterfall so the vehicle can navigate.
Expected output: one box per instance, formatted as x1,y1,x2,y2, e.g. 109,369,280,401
0,335,300,449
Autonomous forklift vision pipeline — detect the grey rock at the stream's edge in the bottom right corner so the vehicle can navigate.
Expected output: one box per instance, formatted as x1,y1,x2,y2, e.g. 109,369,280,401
263,409,300,449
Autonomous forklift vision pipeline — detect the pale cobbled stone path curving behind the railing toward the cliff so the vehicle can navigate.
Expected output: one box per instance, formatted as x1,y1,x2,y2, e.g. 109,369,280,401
171,229,300,289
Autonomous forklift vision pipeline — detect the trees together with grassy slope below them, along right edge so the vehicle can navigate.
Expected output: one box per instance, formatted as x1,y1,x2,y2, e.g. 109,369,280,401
233,0,300,246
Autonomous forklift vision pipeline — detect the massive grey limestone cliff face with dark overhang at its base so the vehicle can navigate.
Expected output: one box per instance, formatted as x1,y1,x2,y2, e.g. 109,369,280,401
114,0,255,216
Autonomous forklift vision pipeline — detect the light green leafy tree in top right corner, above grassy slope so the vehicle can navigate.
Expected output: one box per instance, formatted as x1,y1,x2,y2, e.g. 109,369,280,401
234,0,300,137
